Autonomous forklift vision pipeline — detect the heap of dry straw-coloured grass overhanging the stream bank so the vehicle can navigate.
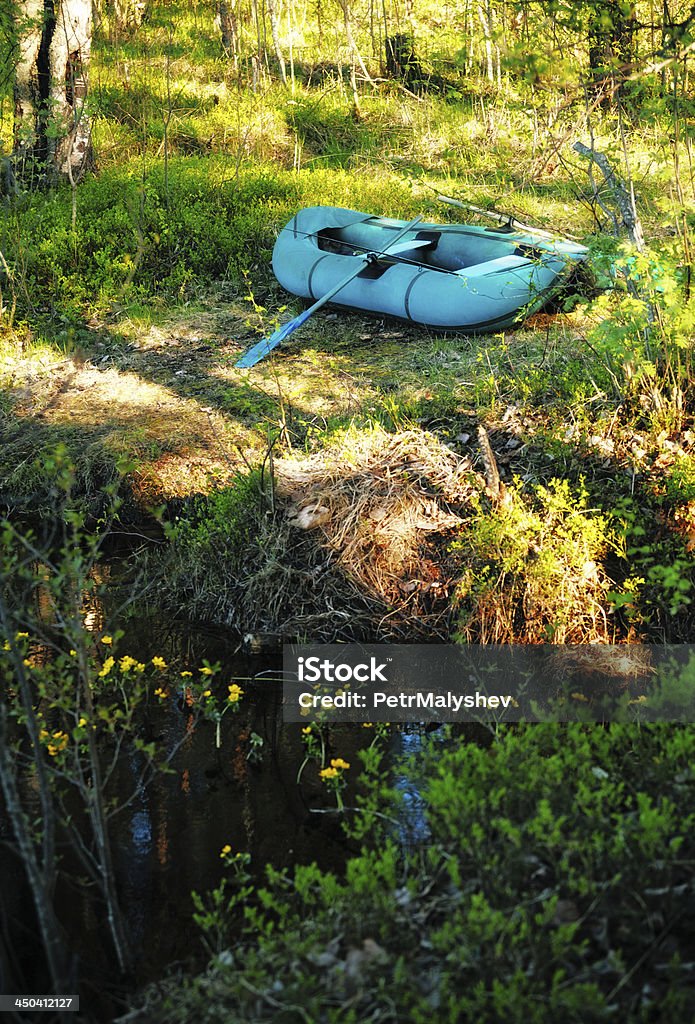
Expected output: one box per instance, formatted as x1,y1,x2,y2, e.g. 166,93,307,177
275,428,483,618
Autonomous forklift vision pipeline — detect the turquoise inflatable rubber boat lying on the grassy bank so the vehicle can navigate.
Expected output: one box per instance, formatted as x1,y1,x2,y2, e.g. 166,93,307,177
272,206,588,333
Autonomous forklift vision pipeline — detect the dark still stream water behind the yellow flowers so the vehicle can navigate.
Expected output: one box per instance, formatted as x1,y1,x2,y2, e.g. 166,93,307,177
0,607,425,1020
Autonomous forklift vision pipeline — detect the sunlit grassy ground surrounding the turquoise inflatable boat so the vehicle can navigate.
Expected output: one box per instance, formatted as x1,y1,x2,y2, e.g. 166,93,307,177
0,0,695,636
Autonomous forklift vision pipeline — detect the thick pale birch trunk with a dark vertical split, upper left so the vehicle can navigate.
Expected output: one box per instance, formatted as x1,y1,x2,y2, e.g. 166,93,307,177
14,0,92,184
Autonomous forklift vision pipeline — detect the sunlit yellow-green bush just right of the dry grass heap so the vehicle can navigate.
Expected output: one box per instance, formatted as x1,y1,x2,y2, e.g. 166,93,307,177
451,479,614,643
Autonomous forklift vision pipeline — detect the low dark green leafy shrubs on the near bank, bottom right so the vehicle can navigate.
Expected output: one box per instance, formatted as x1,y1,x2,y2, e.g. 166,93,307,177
127,725,695,1024
